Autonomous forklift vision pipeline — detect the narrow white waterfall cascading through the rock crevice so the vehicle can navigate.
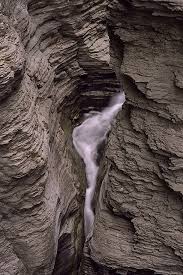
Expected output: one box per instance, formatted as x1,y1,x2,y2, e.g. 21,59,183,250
72,93,125,238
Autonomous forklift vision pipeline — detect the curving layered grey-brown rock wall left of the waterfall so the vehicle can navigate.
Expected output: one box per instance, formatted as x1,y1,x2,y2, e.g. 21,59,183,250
0,0,119,275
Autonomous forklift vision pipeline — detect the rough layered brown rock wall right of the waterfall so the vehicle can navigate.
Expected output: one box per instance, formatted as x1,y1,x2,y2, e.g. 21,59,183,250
90,0,183,275
